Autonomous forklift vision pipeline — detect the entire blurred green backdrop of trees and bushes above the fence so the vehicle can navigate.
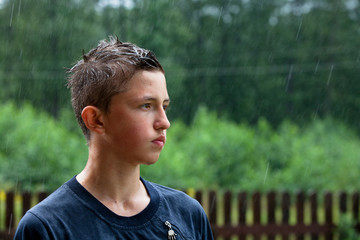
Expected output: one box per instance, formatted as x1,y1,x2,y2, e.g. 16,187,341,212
0,0,360,190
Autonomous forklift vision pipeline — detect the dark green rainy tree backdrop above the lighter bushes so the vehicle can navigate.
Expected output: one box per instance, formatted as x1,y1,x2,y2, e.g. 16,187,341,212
0,0,360,133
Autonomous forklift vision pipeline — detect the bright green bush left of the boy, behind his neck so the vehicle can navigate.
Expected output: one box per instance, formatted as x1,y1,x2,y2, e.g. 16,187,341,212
0,103,87,190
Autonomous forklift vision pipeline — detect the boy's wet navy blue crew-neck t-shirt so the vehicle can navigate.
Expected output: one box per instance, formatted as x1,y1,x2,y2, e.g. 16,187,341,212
14,177,213,240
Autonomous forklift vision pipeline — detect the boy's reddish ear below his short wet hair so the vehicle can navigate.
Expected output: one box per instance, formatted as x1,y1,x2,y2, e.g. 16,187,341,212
81,106,104,133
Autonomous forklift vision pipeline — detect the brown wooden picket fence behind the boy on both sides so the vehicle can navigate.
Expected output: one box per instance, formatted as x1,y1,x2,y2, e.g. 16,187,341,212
0,191,360,240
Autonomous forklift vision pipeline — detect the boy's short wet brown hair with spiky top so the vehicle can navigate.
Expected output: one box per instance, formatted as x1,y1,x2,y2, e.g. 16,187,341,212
67,36,164,141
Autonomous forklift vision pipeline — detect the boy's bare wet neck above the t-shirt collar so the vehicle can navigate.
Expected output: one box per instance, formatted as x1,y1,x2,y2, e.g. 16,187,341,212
76,145,150,216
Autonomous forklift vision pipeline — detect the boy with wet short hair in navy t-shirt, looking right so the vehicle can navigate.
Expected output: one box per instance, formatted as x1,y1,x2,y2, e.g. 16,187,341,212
15,37,213,240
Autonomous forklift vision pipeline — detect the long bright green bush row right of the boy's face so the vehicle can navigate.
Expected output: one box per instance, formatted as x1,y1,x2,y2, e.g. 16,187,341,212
143,108,360,191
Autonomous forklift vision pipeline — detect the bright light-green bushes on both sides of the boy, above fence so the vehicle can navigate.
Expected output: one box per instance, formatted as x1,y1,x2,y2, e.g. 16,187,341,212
0,103,360,191
